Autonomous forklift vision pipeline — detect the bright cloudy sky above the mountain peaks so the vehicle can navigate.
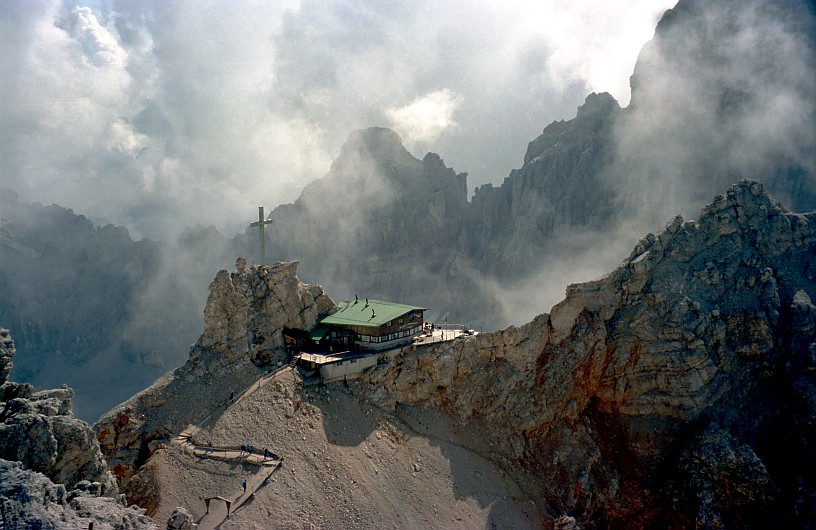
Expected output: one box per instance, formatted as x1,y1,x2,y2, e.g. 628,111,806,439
0,0,676,241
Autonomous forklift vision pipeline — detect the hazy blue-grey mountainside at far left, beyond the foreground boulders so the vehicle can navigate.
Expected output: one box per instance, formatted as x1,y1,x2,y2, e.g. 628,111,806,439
0,190,172,418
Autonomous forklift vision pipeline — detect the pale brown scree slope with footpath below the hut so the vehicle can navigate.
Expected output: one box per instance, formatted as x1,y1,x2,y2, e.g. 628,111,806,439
148,368,541,529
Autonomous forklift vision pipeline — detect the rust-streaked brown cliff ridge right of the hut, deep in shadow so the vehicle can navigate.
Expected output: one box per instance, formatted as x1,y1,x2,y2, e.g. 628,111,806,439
363,181,816,528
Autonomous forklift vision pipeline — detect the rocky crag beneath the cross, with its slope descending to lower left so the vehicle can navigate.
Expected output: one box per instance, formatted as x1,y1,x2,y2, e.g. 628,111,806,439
94,260,335,500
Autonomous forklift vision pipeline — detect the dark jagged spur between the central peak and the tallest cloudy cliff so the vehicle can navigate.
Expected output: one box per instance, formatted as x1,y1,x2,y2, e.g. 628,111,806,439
464,93,621,279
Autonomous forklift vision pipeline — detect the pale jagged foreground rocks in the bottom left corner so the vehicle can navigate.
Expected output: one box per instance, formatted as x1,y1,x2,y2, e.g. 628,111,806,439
0,329,157,530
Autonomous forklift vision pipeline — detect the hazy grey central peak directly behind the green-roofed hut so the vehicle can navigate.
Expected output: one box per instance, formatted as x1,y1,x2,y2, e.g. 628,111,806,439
264,128,498,321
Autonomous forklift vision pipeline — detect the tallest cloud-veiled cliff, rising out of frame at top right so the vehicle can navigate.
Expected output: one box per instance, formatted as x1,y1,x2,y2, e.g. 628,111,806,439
620,0,816,217
